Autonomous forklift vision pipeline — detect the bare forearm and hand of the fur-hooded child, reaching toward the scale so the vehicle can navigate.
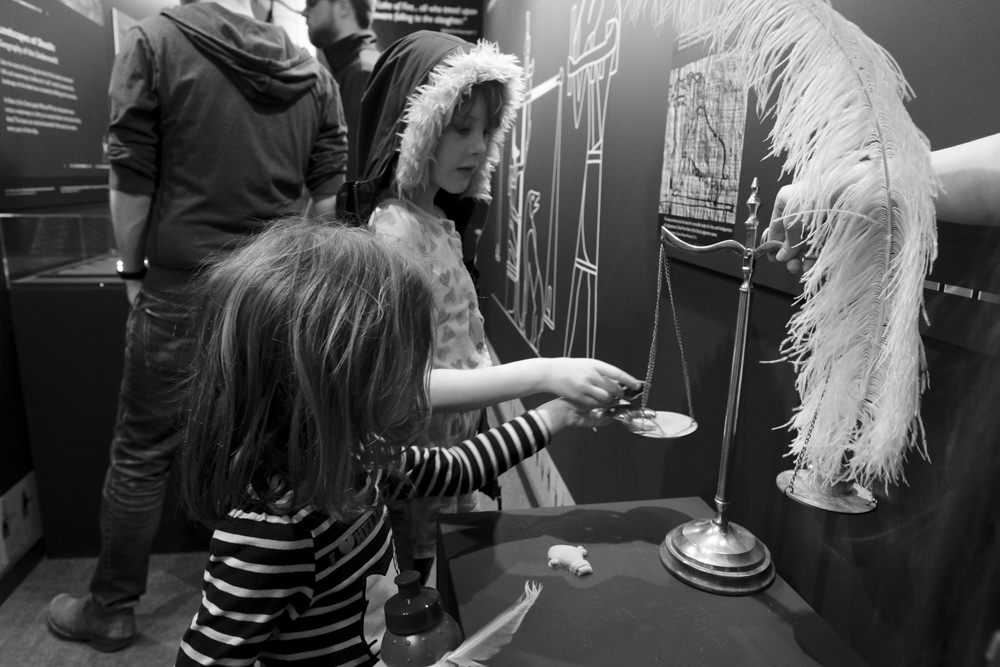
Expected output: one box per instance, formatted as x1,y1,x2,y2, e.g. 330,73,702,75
430,357,642,412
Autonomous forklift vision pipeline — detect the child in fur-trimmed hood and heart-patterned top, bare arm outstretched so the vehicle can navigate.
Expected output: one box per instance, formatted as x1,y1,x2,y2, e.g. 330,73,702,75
338,31,637,580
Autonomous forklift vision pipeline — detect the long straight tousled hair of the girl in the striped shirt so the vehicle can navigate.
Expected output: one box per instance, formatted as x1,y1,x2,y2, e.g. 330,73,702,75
181,219,433,525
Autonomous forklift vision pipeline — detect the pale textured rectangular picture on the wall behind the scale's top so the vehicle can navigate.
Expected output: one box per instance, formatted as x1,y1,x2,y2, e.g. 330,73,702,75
659,55,747,239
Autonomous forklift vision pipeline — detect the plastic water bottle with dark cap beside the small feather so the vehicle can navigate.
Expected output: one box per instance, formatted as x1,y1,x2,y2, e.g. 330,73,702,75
381,570,462,667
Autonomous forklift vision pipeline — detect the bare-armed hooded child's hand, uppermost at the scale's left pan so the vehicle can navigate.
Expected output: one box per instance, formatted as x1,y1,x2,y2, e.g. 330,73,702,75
542,357,642,409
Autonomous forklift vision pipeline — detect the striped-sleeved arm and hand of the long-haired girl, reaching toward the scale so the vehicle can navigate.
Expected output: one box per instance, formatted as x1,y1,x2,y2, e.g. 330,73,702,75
388,398,608,498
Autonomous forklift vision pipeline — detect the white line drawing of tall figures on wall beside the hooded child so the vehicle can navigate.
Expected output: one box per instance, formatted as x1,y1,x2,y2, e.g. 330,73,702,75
493,0,621,357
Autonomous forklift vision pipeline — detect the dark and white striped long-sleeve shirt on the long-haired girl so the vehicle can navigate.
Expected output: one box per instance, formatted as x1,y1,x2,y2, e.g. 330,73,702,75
177,411,550,666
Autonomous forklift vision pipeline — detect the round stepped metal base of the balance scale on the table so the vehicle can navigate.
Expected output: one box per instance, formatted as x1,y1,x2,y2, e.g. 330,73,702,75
660,519,774,595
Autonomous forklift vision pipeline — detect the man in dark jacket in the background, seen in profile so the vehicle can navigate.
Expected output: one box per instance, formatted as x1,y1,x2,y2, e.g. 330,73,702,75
302,0,379,180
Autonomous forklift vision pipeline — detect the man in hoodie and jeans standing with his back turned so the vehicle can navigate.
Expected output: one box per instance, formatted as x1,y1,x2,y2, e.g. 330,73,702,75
48,0,347,651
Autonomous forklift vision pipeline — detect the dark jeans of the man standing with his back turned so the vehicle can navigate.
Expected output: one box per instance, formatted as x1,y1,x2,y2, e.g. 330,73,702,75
90,290,195,611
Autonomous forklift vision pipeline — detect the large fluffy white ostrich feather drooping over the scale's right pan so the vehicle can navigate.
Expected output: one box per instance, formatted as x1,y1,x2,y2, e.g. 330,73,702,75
624,0,938,486
